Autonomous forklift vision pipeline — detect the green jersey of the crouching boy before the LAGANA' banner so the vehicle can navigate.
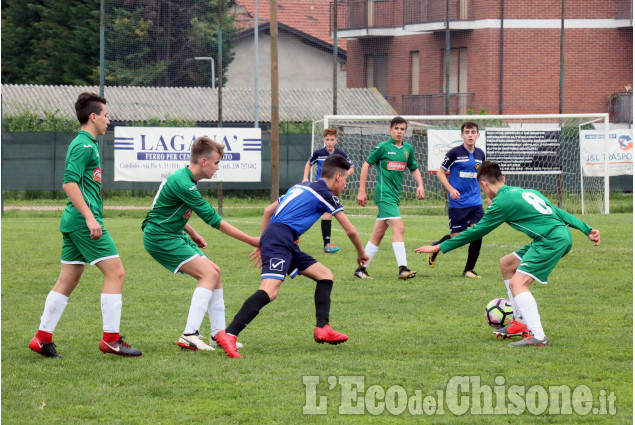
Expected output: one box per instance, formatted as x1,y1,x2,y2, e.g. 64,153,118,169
141,167,222,235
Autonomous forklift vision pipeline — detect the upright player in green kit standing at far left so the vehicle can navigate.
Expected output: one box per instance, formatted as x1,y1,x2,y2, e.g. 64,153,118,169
29,92,142,357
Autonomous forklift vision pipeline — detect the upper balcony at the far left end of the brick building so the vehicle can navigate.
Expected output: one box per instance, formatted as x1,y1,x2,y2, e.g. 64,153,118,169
330,0,402,31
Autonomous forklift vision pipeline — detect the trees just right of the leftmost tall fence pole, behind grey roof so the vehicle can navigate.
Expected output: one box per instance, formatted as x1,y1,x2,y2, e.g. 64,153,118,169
106,0,236,87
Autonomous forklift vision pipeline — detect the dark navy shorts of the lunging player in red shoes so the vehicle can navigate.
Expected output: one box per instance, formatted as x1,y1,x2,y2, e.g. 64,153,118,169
260,223,317,280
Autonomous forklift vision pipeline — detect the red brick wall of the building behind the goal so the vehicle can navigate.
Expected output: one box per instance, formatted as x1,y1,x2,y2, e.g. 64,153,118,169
347,0,633,114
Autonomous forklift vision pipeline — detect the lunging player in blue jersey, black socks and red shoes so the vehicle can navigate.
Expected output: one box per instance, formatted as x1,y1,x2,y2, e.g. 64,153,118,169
214,155,369,358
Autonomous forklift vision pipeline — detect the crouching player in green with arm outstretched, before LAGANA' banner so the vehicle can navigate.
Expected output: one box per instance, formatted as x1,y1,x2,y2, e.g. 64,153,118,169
141,137,259,350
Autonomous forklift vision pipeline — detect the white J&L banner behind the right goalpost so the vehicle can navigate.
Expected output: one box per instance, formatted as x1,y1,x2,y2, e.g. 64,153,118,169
580,129,633,177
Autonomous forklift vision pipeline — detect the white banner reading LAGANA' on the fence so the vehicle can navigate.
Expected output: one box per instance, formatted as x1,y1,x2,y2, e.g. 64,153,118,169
115,127,262,182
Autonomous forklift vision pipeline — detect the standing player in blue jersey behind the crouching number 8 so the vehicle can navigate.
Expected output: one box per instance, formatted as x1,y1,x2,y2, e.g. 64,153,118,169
428,121,485,278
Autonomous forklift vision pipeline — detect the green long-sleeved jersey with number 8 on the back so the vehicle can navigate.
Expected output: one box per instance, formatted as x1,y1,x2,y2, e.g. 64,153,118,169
440,186,591,252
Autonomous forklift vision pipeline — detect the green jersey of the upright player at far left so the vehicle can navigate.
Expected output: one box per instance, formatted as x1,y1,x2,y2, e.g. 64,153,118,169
60,130,104,232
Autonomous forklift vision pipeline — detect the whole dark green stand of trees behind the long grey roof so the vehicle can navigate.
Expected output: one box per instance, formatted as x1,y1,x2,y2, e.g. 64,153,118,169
2,0,236,86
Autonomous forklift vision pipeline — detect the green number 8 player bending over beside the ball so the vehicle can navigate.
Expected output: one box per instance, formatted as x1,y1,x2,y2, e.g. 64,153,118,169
415,161,600,347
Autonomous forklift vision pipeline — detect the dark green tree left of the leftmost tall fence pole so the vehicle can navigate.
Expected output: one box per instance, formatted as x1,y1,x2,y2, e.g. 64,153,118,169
2,0,99,85
